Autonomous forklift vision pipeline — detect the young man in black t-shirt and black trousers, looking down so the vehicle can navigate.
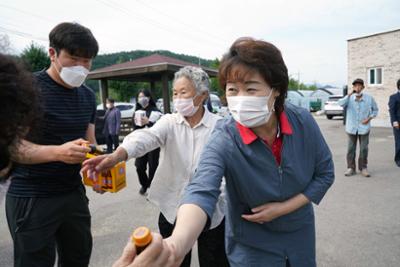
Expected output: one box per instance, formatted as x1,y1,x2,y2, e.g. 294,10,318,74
6,23,98,267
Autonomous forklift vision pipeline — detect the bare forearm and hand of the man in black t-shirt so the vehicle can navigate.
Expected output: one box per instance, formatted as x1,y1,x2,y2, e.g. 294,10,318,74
12,139,90,164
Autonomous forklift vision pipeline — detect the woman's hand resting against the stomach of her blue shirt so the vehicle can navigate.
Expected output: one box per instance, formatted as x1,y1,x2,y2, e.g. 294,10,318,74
242,202,285,224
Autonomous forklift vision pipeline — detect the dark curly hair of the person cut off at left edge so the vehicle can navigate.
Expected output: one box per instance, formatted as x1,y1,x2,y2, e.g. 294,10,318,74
0,54,39,203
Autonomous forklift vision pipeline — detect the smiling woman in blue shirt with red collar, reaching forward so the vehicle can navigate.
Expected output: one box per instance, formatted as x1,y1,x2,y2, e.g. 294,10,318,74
111,38,334,267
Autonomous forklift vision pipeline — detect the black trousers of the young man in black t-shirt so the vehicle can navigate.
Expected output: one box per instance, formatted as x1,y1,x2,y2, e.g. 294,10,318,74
6,186,92,267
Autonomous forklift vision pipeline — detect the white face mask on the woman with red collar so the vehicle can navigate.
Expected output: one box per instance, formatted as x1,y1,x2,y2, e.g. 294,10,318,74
226,92,275,128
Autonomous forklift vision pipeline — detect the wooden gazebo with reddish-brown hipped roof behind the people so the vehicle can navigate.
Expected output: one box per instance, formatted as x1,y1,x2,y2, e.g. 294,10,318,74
88,54,218,113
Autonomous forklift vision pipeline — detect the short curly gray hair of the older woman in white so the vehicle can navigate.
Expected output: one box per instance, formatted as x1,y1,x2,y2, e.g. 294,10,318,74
173,66,210,94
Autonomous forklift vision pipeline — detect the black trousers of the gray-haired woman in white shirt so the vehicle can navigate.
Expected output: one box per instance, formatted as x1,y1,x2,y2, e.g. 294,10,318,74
158,213,229,267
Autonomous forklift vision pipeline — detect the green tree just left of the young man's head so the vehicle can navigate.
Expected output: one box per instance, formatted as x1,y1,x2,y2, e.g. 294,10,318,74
21,42,50,72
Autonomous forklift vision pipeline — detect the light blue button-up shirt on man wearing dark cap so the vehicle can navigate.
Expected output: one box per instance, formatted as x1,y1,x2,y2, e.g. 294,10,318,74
338,93,378,134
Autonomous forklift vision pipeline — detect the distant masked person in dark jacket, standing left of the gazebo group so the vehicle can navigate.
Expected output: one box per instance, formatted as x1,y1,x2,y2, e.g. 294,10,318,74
103,98,121,153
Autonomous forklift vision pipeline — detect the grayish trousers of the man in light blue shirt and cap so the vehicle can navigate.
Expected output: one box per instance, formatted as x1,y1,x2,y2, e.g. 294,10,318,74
347,133,369,171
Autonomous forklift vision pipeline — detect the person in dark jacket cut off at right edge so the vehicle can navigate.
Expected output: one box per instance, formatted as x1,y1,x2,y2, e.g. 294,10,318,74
389,79,400,167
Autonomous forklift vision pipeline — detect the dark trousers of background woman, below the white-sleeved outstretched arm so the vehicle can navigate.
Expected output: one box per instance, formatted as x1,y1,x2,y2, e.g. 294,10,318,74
135,148,160,189
